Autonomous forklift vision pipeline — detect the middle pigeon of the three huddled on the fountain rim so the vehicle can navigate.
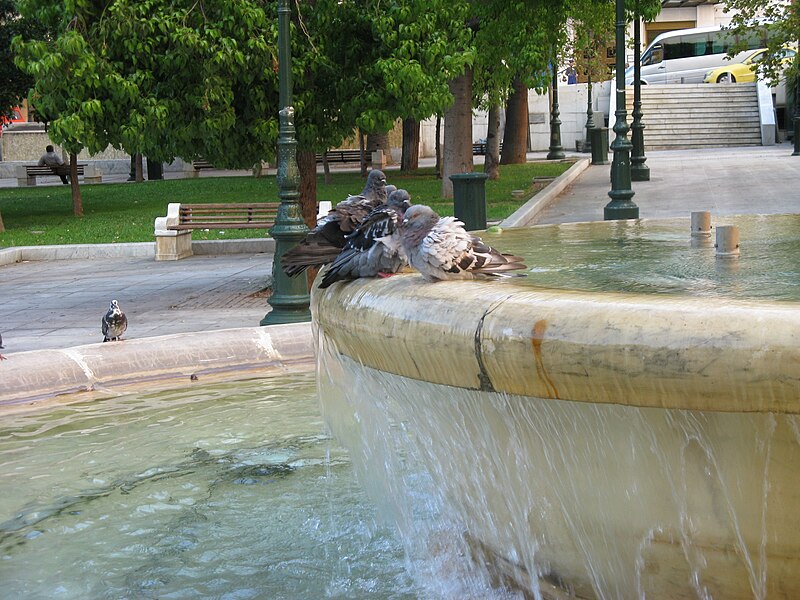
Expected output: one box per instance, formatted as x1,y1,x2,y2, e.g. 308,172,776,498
319,190,411,288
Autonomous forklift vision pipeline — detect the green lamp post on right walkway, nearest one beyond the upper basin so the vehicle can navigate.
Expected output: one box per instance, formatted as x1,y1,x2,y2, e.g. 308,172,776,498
603,0,639,221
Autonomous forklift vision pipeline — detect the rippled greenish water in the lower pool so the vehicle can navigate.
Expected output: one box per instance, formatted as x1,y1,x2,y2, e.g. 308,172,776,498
0,374,421,599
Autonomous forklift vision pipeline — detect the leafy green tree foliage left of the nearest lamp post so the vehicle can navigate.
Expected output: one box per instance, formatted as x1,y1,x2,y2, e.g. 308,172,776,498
16,0,277,166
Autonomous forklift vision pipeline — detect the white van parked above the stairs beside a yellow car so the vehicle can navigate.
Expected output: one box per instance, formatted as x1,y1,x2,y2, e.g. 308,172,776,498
625,26,767,85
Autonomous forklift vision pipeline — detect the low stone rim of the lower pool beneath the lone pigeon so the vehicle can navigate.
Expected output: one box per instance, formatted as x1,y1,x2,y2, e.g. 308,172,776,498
0,323,315,414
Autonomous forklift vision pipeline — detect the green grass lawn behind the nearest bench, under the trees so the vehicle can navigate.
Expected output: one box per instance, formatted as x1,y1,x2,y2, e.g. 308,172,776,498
0,161,572,247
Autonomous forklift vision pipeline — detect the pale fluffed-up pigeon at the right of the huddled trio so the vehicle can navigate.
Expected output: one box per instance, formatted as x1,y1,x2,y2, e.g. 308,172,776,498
400,204,527,281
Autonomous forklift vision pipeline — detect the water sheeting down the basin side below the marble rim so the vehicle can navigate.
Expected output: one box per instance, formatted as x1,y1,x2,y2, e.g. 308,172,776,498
319,328,800,600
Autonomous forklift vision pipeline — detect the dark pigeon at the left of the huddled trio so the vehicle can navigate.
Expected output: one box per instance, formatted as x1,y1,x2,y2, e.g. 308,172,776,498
281,169,386,277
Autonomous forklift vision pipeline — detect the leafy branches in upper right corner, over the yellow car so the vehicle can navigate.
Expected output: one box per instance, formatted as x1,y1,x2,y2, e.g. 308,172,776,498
725,0,800,85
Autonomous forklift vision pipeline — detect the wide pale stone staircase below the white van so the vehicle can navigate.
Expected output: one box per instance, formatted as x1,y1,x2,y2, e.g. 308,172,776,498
624,83,761,150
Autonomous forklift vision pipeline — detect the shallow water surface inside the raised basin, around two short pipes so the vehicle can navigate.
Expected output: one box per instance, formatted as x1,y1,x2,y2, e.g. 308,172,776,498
482,215,800,301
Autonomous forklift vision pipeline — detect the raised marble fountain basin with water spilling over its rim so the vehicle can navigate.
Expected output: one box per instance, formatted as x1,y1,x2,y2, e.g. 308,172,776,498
312,216,800,599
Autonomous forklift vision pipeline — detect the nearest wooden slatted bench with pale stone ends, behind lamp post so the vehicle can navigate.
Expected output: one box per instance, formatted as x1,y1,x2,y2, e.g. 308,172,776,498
155,202,331,260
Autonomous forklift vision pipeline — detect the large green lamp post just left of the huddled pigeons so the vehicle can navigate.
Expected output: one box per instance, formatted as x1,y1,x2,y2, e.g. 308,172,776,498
261,0,311,325
